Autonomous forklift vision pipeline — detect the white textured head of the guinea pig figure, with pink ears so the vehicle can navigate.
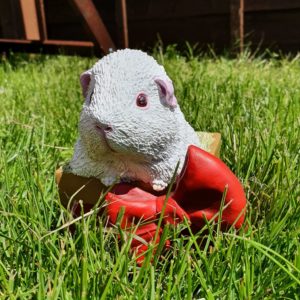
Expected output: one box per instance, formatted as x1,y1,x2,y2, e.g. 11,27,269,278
79,49,181,162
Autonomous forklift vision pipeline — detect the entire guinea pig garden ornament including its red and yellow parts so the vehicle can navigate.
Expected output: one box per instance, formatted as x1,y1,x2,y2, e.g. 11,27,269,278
56,49,246,260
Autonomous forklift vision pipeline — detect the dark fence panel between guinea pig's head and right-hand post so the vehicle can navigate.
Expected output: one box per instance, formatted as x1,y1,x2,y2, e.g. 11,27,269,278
127,0,230,49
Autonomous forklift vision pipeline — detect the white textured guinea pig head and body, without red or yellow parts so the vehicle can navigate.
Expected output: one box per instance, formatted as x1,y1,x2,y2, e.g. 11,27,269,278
70,49,201,191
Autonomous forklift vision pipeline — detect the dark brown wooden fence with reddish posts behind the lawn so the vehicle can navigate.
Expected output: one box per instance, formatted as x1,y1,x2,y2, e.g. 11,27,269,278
0,0,300,54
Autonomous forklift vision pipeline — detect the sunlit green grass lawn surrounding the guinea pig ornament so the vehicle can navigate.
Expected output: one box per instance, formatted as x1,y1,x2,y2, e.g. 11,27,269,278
0,47,300,299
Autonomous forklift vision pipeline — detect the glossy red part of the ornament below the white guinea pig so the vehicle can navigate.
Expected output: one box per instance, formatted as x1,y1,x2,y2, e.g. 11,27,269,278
102,146,246,263
